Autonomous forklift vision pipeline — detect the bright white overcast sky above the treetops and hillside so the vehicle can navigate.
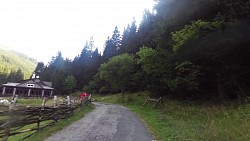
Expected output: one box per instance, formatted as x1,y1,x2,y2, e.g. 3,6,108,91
0,0,155,63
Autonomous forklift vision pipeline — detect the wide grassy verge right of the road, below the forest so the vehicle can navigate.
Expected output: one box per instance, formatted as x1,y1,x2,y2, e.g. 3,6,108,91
94,93,250,141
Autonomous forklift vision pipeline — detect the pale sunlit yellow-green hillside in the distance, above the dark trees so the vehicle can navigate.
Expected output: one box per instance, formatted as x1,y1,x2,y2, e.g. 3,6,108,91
0,45,37,82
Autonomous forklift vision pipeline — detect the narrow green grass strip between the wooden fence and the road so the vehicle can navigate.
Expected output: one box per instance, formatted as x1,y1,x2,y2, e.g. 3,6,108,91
8,104,94,141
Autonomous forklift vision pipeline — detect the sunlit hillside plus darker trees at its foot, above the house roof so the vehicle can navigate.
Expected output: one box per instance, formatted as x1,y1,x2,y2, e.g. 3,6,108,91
0,46,36,84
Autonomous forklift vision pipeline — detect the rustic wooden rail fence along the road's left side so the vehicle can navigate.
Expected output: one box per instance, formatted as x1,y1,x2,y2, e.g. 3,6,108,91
0,96,89,141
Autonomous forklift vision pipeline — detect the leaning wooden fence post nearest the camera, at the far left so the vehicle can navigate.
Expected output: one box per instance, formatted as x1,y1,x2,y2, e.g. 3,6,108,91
2,95,18,141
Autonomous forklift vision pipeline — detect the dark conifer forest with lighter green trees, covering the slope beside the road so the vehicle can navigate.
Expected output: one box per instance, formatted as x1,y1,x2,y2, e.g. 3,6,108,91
36,0,250,102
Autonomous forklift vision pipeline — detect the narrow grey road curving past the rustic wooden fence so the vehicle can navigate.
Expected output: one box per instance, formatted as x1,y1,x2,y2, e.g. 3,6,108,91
45,103,153,141
